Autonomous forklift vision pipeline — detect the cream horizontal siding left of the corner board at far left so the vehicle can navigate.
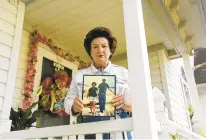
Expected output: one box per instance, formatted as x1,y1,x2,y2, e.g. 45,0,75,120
0,0,17,115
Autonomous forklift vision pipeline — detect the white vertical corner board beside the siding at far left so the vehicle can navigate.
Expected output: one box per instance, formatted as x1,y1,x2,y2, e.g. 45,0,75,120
1,1,25,119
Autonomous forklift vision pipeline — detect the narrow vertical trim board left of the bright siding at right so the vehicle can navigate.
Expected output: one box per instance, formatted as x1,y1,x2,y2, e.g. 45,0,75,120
158,50,173,120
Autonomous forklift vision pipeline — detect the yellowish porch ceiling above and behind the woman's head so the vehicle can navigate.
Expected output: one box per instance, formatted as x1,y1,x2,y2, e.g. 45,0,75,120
25,0,179,61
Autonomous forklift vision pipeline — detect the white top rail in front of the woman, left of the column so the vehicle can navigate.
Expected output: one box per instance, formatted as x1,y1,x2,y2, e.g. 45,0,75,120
2,118,132,139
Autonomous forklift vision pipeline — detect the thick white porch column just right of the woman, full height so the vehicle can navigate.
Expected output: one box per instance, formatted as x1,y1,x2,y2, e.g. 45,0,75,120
123,0,158,140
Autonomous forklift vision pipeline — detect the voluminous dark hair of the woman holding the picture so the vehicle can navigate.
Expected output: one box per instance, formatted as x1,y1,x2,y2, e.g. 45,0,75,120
84,27,117,59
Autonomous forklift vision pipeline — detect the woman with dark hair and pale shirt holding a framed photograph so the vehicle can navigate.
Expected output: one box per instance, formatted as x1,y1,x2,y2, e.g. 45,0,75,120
64,27,132,139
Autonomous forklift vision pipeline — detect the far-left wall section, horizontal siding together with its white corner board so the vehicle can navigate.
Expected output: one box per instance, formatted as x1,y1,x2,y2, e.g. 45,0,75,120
0,0,25,133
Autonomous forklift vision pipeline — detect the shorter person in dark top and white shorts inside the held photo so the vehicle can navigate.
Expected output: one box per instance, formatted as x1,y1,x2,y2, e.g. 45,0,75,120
87,82,98,115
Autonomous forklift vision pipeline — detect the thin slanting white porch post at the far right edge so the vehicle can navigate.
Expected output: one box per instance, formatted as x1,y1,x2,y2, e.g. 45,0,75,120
182,53,206,127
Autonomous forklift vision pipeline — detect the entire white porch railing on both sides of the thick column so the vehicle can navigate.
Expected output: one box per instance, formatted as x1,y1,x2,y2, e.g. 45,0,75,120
0,88,205,140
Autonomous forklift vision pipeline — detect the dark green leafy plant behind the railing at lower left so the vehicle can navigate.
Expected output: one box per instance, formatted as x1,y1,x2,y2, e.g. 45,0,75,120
9,102,43,131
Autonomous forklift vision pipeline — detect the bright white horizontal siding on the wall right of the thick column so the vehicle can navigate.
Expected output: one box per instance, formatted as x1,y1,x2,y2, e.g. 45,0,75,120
162,50,189,128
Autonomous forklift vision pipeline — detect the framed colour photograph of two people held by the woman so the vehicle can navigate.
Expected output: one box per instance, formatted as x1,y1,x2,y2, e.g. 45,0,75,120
82,75,116,117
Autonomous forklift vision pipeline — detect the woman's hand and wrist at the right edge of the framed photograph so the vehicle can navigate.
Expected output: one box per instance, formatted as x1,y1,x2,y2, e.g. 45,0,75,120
112,95,132,112
